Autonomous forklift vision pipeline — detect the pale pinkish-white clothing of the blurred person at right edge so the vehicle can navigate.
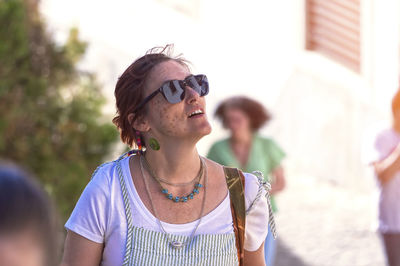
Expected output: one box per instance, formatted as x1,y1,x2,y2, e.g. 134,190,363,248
368,129,400,233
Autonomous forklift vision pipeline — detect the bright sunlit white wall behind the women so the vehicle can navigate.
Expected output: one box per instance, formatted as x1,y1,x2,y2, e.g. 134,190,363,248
41,0,400,188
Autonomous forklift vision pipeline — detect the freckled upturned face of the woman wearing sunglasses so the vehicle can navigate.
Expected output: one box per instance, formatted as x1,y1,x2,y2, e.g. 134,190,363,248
141,60,211,140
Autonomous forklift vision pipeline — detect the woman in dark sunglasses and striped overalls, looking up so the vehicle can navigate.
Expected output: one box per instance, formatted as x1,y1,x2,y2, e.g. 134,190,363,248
62,46,269,266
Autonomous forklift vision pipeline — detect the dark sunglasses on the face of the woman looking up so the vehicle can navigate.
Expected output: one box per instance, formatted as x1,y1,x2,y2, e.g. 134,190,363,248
133,75,208,113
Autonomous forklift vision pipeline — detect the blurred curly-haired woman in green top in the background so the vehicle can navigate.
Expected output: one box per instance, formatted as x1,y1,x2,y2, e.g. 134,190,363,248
207,96,285,266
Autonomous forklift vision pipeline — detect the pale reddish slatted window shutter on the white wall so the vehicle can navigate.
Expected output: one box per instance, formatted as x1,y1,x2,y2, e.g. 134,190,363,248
306,0,361,72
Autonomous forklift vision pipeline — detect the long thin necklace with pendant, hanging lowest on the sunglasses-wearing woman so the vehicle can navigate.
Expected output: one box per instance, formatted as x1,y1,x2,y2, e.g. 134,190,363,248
140,156,207,249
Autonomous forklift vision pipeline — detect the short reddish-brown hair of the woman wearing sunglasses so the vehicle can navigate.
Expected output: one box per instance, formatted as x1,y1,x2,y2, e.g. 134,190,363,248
112,44,189,146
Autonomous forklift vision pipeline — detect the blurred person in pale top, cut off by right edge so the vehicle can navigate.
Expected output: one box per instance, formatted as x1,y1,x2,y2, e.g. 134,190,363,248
369,90,400,266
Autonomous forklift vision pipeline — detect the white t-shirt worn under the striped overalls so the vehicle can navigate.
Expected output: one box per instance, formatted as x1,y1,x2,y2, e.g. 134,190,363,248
65,157,269,265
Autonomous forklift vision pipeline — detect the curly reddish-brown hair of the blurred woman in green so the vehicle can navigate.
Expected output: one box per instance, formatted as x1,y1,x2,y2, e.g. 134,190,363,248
215,96,271,131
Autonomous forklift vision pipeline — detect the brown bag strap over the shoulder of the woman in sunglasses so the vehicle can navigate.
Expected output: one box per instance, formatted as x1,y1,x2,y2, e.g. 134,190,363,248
224,166,246,266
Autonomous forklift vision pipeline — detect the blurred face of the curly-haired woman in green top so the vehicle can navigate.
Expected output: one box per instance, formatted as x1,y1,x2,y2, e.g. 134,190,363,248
224,108,251,134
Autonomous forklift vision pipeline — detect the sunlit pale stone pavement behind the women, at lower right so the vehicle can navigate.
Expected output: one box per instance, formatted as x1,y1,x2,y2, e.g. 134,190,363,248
275,170,385,266
